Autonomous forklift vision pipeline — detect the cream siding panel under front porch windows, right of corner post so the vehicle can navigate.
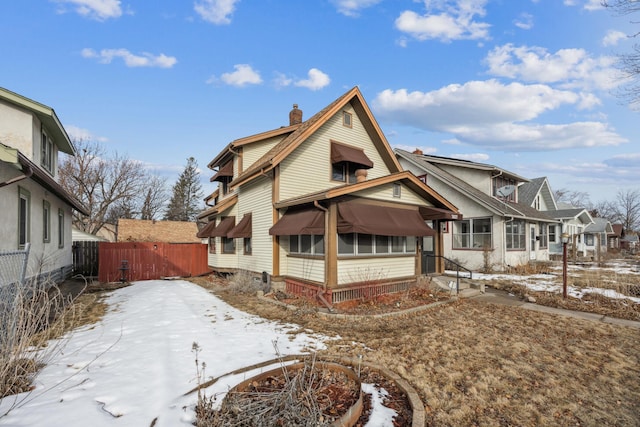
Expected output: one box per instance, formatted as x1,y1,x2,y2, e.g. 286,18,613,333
338,256,416,285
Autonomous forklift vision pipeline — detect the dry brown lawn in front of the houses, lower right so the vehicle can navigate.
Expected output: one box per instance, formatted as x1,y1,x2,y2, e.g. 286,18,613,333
195,282,640,426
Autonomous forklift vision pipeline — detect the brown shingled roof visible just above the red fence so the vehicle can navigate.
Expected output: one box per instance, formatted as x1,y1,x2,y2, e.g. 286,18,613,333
116,218,201,243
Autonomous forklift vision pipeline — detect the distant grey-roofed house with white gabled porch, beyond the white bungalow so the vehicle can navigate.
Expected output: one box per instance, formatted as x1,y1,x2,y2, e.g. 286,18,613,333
518,177,594,256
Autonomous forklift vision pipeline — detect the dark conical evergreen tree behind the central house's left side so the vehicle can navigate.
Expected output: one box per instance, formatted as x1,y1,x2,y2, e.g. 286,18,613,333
164,157,204,221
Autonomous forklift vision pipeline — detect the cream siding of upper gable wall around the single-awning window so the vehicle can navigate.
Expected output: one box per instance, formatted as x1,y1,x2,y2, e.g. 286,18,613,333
280,107,390,200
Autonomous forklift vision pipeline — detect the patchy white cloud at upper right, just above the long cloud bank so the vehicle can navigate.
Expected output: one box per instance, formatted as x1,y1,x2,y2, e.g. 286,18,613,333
485,43,620,90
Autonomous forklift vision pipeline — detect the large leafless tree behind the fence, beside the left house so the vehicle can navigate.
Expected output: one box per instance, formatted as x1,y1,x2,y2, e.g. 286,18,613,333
60,140,166,234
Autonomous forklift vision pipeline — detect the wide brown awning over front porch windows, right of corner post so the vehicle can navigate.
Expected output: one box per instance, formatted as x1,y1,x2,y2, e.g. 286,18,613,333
338,202,436,236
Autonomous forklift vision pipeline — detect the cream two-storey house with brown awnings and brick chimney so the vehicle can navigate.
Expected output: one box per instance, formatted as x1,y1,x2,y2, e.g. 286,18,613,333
198,87,459,301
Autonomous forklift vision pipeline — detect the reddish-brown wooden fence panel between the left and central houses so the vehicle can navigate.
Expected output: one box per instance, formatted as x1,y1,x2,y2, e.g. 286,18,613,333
98,242,210,282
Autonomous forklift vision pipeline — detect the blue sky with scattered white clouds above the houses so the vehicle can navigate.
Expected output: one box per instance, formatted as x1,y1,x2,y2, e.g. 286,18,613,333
0,0,640,203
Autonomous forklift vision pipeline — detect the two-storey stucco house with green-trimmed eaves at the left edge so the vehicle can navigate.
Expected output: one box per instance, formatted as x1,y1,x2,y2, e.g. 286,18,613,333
0,88,87,281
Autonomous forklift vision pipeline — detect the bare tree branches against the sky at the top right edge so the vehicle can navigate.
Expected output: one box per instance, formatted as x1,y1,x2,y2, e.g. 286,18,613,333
602,0,640,107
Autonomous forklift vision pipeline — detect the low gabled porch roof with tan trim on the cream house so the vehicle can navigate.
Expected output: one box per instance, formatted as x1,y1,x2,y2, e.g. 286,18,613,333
274,171,459,213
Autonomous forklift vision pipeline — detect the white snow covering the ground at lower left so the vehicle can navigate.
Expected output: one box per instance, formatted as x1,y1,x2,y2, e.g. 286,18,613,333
0,280,329,427
